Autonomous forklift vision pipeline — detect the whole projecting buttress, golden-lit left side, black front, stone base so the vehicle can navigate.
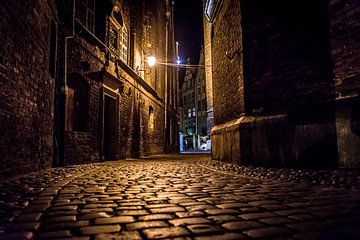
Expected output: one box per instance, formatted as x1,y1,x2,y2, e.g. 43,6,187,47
210,0,338,167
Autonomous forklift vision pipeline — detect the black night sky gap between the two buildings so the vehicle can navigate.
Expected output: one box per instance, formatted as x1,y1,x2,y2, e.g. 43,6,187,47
174,0,204,64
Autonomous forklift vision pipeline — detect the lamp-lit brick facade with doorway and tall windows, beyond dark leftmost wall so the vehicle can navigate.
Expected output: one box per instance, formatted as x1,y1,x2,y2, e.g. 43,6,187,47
59,0,179,163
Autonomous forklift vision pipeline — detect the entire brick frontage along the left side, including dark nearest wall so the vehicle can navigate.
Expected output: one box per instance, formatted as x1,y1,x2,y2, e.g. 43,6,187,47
0,0,179,176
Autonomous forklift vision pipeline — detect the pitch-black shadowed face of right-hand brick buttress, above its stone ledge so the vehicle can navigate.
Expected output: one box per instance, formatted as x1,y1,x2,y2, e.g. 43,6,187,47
241,0,333,113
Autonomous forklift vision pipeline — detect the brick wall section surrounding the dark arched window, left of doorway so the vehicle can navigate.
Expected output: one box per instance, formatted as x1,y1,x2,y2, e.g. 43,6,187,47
64,37,105,164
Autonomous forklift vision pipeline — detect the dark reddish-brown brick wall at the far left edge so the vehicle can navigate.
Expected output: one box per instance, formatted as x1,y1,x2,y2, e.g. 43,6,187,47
0,0,54,174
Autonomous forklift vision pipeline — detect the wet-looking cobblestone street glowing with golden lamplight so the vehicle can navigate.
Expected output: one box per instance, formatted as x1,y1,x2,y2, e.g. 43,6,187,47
0,155,360,240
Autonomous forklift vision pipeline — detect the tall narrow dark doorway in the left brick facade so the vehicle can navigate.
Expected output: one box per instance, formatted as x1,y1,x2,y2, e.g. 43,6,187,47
103,94,118,160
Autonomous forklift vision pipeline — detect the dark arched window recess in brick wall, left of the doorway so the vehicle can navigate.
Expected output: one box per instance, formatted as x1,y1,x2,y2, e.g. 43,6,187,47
66,76,89,132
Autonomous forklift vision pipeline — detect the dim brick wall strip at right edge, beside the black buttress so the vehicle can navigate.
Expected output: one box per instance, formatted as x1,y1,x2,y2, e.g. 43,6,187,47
329,0,360,167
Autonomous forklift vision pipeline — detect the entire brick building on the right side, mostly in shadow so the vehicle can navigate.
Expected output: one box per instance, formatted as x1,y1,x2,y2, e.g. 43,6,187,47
204,0,360,167
